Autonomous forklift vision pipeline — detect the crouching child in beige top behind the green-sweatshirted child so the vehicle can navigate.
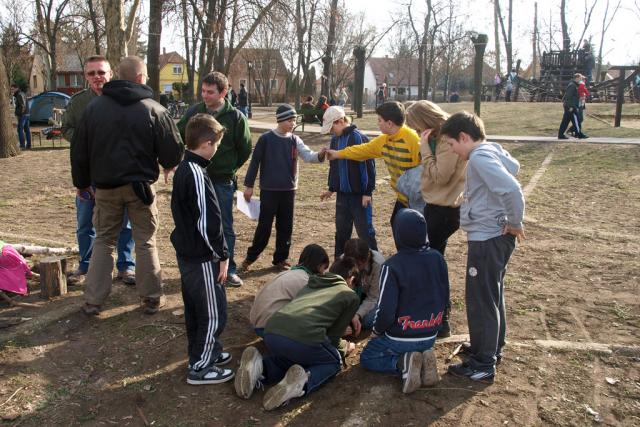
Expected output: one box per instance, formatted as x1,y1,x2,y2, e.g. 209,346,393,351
249,243,329,337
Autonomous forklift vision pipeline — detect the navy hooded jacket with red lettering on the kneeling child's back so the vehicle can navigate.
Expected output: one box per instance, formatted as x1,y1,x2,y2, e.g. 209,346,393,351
373,209,449,341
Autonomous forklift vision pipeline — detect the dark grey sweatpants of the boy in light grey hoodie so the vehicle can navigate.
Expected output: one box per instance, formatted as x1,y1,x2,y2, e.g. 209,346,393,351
465,235,516,370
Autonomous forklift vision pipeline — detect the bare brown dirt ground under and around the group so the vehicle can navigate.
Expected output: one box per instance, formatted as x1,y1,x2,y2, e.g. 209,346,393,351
0,135,640,426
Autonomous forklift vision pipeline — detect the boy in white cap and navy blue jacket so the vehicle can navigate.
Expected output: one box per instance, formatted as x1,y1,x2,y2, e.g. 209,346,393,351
320,106,378,259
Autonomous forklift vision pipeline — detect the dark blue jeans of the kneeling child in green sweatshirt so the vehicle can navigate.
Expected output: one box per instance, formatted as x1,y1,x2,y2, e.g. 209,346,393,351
262,333,342,395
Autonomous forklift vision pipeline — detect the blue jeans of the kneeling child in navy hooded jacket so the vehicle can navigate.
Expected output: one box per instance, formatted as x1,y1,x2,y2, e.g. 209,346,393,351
360,335,436,375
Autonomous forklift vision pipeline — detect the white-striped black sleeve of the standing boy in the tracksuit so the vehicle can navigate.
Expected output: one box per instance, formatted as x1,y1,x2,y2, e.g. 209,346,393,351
189,163,228,260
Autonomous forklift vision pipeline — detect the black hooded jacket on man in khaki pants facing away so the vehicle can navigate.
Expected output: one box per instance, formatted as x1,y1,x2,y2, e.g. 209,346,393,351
71,80,184,188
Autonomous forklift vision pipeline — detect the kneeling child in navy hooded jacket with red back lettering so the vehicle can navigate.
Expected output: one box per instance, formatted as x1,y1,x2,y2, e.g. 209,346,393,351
360,209,449,393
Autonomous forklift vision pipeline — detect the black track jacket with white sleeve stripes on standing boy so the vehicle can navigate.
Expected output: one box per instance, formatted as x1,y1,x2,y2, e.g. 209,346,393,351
171,151,228,262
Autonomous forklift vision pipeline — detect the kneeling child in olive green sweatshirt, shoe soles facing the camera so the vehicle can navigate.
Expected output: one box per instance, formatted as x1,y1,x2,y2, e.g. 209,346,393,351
235,258,360,411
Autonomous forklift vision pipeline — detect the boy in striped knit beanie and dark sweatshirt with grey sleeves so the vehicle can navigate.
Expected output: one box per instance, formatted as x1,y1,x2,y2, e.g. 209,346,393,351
240,104,326,271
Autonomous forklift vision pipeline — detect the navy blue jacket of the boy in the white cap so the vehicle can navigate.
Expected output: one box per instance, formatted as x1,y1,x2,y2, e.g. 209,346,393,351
328,125,376,196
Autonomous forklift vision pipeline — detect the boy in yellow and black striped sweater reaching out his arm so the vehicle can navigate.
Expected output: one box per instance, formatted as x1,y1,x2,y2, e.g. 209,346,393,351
326,101,420,225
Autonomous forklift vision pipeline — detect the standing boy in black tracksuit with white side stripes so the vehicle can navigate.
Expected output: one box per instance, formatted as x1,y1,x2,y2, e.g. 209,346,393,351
171,114,234,385
